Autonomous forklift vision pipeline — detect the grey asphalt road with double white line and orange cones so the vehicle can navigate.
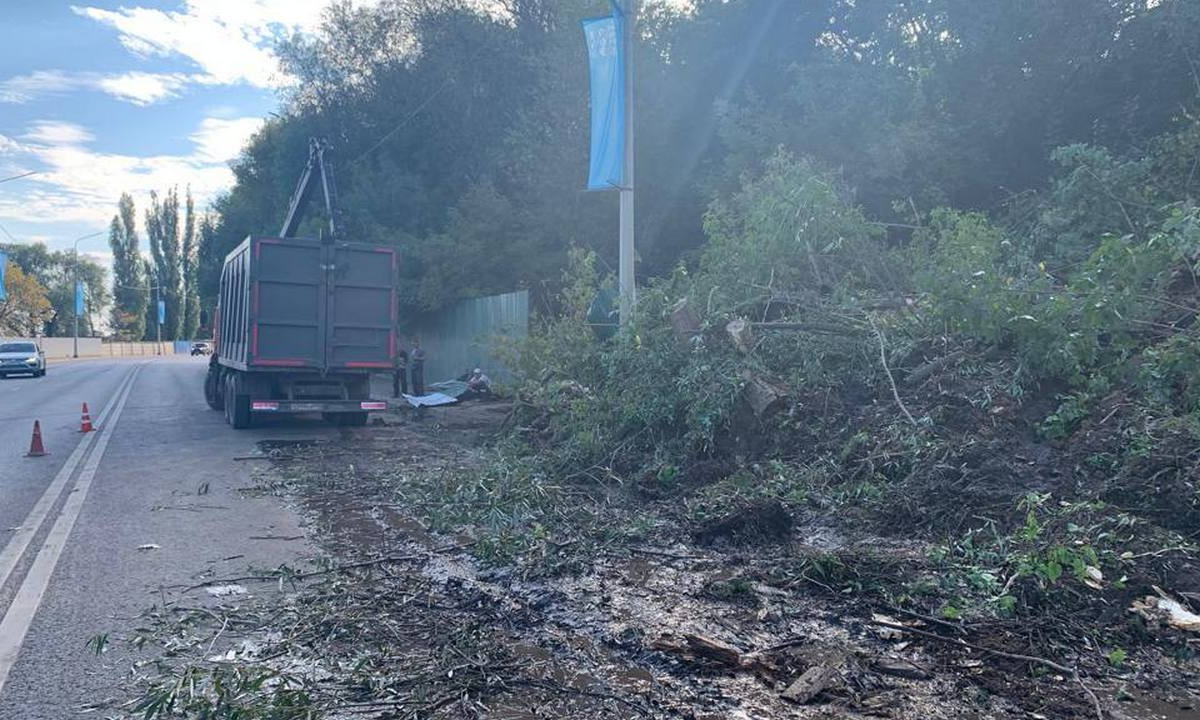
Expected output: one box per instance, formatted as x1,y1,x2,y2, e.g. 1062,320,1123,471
0,358,337,720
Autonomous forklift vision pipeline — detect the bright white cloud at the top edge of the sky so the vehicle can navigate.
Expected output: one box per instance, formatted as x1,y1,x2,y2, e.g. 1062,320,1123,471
71,0,377,88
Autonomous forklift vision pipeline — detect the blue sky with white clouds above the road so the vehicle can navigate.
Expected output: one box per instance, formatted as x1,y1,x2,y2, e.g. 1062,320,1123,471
0,0,359,262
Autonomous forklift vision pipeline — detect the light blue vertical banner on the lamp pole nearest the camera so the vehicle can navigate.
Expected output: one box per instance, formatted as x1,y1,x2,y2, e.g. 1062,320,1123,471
583,7,625,190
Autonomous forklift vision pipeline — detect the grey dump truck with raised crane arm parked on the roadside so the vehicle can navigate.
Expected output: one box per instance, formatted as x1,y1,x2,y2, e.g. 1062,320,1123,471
204,140,398,428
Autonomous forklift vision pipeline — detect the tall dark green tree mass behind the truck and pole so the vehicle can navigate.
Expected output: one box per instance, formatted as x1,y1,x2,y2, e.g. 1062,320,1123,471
199,0,1200,324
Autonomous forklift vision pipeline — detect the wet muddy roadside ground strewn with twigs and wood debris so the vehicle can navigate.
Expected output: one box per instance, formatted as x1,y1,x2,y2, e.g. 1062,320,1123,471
192,402,1200,720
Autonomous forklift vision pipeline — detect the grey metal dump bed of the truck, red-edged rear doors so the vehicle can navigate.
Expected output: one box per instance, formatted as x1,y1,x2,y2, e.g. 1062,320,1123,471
217,236,397,372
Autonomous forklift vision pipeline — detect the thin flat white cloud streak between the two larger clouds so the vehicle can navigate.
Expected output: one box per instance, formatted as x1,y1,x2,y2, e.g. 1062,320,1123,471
0,70,195,106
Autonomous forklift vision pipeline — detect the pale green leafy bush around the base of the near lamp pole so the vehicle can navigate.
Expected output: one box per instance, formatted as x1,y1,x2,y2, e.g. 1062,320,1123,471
508,154,894,484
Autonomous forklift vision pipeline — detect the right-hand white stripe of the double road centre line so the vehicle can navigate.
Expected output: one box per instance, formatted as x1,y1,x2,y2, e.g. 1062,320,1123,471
0,367,140,694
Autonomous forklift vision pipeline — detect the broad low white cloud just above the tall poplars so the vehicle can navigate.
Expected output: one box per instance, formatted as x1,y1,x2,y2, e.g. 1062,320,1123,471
0,118,262,229
